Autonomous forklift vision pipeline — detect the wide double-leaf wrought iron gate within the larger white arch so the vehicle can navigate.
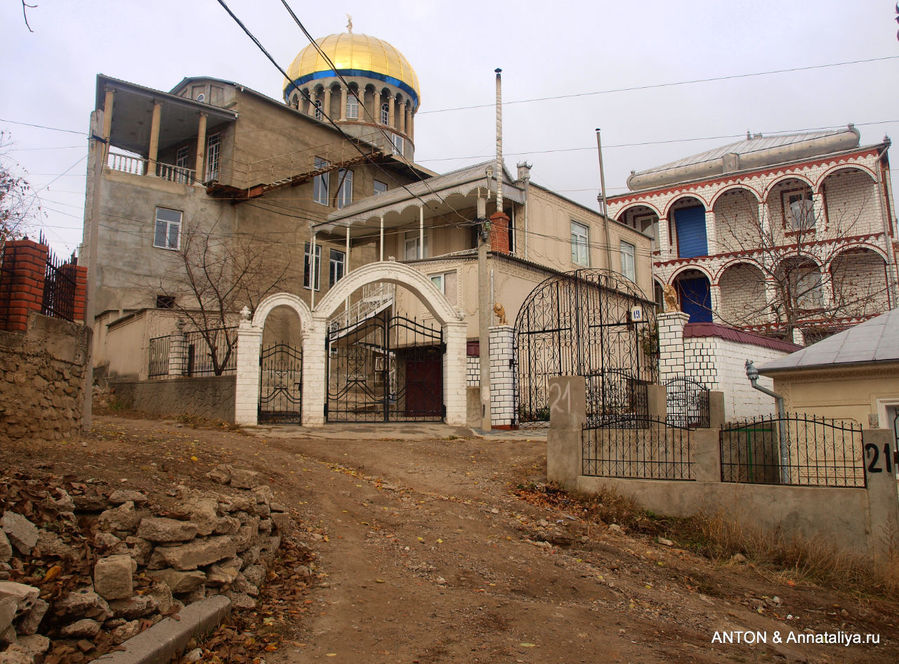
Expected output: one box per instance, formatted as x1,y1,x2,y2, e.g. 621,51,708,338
325,312,445,422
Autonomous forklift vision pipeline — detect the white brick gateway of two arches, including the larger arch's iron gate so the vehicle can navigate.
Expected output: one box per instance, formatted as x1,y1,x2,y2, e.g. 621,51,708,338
235,261,466,426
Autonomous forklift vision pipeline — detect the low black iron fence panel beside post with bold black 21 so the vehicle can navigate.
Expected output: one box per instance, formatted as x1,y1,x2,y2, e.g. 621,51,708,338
720,414,866,487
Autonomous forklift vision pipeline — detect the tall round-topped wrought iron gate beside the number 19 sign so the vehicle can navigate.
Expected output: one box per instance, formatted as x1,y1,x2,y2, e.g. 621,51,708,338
515,269,658,426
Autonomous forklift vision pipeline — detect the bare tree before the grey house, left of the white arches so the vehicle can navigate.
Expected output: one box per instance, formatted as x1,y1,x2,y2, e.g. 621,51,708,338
160,219,291,376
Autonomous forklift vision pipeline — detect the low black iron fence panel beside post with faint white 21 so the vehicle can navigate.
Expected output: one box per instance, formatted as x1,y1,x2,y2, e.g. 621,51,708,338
581,417,695,480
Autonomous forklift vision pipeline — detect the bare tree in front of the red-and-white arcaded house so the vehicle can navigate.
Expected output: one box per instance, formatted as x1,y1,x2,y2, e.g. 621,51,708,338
716,183,892,341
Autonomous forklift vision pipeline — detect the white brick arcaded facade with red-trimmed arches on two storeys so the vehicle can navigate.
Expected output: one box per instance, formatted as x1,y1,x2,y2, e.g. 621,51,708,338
609,148,899,329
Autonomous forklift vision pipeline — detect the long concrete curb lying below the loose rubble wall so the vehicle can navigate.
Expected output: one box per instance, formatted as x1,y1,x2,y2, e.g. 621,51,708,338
94,595,231,664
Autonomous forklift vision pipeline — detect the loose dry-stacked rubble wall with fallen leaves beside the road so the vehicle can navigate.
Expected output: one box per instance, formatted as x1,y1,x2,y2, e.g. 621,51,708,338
0,465,291,663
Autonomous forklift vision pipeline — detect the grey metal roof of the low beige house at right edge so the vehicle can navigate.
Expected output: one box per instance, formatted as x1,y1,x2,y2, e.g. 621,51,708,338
759,309,899,373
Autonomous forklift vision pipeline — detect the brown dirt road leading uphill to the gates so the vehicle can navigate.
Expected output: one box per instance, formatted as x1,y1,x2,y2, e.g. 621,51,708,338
0,417,899,664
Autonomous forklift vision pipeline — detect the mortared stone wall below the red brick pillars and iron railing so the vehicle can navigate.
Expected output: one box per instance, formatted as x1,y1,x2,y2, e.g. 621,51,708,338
0,313,91,439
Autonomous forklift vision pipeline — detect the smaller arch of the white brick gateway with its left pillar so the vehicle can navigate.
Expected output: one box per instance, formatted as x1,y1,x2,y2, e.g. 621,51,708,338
234,293,313,426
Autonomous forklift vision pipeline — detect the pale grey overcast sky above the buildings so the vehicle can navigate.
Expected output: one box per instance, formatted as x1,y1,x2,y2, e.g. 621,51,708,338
0,0,899,253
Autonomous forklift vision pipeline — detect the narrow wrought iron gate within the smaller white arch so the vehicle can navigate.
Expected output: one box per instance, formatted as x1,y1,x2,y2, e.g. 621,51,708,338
258,344,303,424
